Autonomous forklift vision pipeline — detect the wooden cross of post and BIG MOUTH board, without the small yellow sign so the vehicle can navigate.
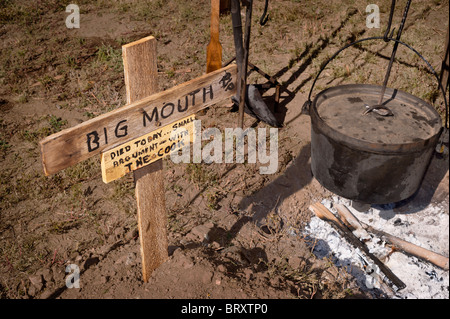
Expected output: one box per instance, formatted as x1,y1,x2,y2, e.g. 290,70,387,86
40,37,237,282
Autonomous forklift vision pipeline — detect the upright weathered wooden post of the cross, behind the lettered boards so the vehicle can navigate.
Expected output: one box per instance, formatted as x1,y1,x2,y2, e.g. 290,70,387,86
122,37,168,282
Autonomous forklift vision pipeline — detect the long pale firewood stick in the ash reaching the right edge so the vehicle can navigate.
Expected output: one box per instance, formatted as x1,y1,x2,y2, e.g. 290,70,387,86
334,204,449,270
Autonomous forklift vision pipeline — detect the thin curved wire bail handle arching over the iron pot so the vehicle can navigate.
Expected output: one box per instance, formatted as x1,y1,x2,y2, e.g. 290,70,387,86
302,36,448,131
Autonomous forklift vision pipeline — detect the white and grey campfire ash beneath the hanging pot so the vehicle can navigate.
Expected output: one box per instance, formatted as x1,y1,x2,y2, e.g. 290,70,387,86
305,196,449,299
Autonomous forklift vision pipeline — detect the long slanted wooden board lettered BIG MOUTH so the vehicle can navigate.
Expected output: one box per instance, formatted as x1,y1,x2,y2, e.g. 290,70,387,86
40,64,237,175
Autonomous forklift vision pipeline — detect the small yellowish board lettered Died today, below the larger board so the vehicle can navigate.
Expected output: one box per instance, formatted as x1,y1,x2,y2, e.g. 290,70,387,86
101,115,195,183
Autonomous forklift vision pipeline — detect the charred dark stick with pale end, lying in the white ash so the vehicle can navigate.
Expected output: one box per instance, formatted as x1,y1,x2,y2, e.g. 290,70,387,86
309,203,406,291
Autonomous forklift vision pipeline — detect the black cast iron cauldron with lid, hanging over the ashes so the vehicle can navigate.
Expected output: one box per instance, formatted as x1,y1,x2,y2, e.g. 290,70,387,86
305,38,448,204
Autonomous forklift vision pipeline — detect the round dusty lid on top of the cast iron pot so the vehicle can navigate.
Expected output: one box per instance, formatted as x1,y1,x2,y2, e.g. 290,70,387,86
313,84,442,145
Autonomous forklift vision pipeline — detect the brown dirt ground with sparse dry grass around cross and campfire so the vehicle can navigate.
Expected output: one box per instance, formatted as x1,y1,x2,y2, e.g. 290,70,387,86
0,0,449,299
